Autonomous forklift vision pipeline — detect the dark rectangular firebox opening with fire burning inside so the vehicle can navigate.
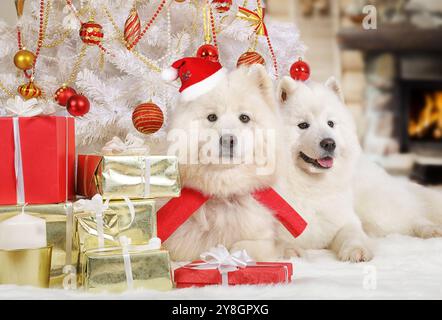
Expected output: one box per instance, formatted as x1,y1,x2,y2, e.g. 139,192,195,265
397,81,442,155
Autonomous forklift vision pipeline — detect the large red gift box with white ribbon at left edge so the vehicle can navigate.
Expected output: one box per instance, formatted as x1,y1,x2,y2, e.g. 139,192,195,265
0,116,75,205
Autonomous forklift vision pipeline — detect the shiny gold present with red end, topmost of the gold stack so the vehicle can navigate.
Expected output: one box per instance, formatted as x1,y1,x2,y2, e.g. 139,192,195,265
77,134,181,199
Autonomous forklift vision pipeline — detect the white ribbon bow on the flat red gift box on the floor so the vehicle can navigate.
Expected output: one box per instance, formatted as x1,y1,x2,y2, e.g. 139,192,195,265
188,245,255,286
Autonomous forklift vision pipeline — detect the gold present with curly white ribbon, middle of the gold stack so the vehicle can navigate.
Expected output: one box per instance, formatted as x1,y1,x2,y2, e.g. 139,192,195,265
74,195,157,254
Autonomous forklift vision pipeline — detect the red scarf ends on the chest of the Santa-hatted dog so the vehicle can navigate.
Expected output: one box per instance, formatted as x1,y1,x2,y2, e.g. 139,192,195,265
157,188,307,241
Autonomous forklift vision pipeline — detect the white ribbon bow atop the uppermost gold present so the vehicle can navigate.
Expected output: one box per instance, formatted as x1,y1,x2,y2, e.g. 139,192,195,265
101,133,149,155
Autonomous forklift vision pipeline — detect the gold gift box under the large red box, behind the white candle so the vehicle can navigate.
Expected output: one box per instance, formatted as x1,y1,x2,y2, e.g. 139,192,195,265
0,202,77,287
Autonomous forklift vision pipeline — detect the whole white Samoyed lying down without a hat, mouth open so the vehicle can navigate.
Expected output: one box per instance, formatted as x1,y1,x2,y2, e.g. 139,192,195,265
277,77,442,262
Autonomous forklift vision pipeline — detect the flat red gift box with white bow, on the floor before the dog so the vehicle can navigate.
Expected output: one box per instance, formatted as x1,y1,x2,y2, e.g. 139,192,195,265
174,246,293,288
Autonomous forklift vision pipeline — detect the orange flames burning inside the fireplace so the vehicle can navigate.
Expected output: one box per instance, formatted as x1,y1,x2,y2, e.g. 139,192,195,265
408,91,442,139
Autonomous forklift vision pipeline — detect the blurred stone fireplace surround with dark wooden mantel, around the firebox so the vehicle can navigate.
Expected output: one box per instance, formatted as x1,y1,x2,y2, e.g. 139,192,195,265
338,25,442,183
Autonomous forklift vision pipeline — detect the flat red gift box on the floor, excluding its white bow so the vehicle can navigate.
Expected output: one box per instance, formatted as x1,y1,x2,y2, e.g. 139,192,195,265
174,261,293,288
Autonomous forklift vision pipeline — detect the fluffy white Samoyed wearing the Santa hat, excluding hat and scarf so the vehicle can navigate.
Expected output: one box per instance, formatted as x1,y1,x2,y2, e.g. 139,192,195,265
165,65,283,261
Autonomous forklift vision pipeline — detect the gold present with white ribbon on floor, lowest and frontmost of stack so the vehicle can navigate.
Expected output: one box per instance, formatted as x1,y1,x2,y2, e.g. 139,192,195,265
81,237,173,292
